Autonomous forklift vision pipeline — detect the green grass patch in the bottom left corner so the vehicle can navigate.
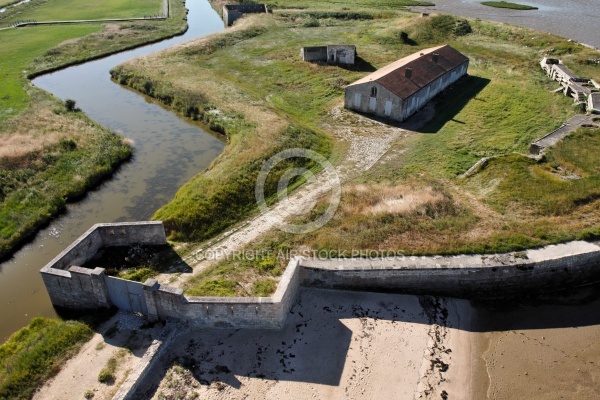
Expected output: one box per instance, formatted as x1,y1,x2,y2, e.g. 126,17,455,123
0,317,93,400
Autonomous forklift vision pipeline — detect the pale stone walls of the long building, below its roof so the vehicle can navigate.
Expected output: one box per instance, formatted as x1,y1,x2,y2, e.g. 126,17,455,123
344,62,469,122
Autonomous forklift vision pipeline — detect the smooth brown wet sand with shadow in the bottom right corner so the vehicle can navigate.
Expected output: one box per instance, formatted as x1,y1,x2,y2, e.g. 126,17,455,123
473,287,600,399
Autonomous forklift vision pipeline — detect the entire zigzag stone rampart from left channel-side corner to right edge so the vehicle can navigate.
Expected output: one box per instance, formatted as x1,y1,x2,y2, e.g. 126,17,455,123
40,222,600,329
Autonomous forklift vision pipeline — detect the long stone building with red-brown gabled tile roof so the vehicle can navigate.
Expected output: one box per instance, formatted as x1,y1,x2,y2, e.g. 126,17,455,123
344,45,469,121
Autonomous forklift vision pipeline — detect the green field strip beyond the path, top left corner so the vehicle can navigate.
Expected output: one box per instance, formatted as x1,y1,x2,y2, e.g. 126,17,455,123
0,0,162,26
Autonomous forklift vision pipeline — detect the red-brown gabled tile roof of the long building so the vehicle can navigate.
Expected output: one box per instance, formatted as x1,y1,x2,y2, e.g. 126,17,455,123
349,45,469,99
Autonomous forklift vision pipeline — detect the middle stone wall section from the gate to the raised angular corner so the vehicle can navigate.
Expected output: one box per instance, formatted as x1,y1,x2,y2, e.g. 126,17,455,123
144,259,300,329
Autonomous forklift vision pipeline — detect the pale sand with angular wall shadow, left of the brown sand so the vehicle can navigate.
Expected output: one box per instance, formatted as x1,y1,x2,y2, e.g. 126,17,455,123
134,289,476,399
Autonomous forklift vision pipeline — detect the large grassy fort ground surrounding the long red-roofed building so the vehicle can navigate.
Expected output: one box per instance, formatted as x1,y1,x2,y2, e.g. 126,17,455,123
115,0,600,295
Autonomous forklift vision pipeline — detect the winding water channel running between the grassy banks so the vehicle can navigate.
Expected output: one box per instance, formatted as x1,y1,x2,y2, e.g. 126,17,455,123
0,0,225,343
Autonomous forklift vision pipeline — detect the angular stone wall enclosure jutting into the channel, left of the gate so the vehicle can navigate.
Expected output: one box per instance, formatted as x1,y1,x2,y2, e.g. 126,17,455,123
40,222,166,309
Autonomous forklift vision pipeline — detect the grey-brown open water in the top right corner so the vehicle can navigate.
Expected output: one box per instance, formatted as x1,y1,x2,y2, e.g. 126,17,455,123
415,0,600,48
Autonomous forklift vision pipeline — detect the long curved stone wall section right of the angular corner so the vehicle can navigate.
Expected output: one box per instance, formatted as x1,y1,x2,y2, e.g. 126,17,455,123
301,242,600,299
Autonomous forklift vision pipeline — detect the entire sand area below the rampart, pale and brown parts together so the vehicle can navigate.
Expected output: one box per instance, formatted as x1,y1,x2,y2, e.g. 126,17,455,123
132,287,600,400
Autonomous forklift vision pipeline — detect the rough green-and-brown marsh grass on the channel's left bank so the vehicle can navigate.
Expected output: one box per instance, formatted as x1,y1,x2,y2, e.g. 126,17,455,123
0,89,131,257
